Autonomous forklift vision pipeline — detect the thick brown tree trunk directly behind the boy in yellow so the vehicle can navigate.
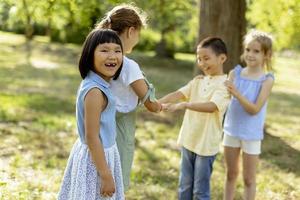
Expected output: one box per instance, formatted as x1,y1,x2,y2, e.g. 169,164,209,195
195,0,246,73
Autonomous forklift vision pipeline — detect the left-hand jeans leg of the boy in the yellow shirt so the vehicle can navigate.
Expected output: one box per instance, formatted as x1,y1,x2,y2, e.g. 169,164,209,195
178,147,196,200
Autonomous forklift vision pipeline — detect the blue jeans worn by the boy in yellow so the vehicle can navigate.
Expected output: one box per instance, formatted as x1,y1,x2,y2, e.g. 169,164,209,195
178,147,216,200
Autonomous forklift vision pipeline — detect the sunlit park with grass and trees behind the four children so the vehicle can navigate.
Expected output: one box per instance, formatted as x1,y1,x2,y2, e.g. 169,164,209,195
0,0,300,200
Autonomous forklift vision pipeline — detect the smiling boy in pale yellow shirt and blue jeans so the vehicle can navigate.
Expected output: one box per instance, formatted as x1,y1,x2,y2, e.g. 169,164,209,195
159,37,230,200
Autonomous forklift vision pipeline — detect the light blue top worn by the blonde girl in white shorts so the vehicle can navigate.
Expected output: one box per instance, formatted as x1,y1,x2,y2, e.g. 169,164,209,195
224,65,274,140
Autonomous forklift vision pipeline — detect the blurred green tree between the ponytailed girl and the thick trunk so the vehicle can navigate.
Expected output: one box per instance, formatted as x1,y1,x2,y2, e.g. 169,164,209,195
136,0,197,58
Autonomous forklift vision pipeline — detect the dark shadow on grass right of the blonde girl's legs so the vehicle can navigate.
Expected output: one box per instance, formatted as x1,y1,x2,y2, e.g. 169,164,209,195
260,133,300,177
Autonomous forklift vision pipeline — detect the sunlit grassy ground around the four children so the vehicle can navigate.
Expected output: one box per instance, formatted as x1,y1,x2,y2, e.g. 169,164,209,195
0,32,300,200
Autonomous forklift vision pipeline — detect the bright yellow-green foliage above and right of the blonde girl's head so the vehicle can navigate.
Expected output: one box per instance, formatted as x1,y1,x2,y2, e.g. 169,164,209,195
246,0,300,50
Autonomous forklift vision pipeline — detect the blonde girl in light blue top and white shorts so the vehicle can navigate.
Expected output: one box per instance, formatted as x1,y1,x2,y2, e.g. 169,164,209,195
223,31,274,200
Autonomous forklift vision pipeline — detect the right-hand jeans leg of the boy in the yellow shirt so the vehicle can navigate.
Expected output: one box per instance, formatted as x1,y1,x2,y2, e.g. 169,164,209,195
193,155,216,200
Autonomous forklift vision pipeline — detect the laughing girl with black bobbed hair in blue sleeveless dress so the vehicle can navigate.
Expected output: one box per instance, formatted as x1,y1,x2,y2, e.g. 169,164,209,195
58,29,124,200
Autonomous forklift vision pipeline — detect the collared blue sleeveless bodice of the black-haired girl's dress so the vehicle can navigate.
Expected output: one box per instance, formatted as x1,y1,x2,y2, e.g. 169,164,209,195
76,71,116,148
